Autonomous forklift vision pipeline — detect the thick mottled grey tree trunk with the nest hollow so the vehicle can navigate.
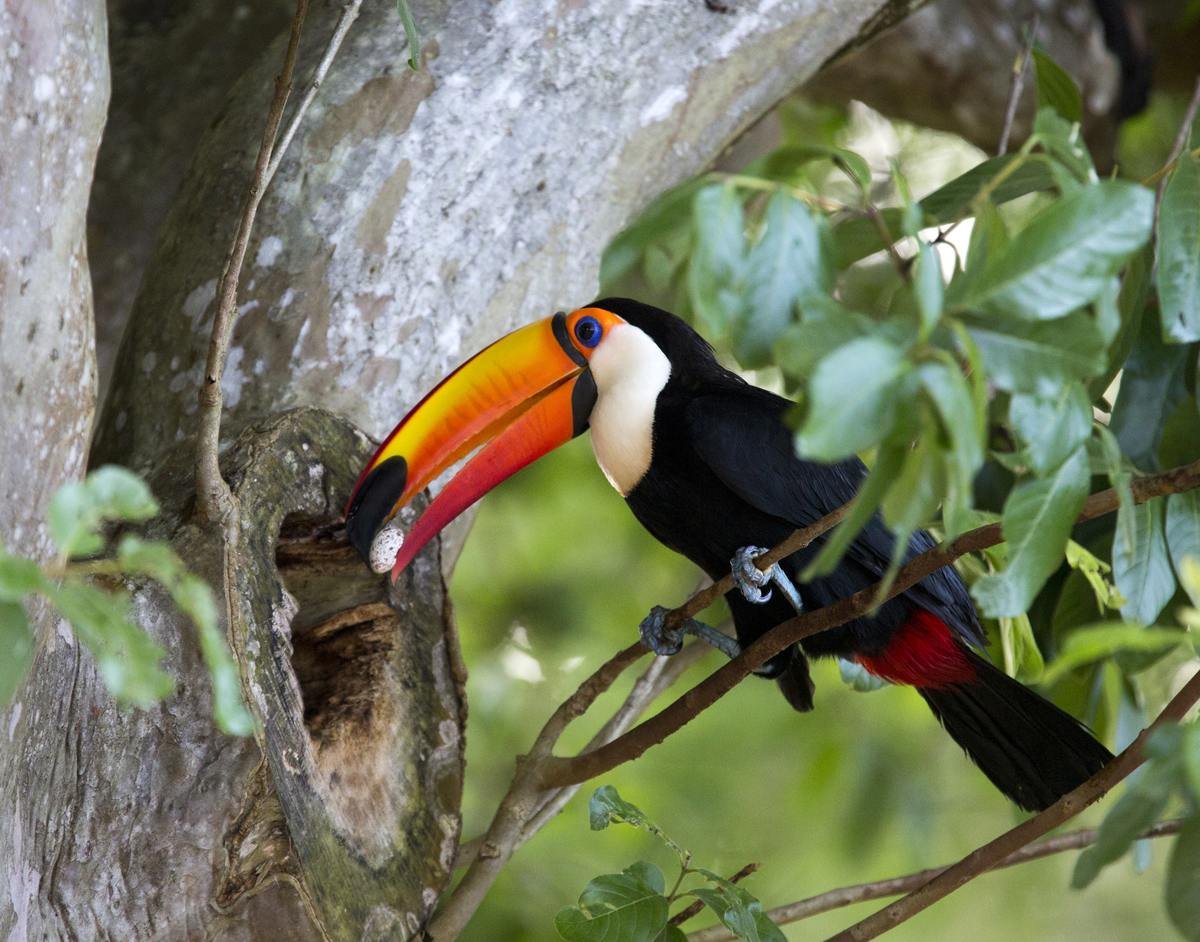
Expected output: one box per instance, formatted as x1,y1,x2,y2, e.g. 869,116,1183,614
0,0,931,940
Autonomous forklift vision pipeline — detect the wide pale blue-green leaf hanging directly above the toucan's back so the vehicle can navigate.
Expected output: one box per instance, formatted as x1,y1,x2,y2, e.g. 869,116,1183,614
733,193,833,367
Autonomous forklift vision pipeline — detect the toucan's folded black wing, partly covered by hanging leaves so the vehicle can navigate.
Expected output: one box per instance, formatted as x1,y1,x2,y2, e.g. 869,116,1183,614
685,386,983,643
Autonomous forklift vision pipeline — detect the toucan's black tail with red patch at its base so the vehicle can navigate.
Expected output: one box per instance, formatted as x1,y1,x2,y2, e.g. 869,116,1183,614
859,612,1112,811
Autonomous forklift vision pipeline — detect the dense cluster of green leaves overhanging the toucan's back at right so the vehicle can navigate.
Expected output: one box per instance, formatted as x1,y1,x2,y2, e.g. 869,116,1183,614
604,49,1200,940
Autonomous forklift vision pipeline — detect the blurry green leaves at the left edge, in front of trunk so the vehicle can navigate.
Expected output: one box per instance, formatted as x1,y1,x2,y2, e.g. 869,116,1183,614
0,464,252,736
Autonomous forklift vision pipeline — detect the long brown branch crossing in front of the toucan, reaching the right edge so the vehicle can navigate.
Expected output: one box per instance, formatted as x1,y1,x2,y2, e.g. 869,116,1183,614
540,461,1200,787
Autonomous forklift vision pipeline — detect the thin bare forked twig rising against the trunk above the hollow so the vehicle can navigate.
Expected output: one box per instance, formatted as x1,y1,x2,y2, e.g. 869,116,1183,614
196,0,362,524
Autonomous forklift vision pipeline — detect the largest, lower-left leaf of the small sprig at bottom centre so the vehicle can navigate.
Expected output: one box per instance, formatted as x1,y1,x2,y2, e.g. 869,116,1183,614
554,863,668,942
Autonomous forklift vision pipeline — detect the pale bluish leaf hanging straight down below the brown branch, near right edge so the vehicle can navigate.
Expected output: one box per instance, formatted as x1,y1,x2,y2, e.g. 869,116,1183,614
1112,497,1175,625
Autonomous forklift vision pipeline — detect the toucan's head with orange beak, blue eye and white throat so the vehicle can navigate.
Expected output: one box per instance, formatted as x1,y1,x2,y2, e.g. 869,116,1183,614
346,299,715,578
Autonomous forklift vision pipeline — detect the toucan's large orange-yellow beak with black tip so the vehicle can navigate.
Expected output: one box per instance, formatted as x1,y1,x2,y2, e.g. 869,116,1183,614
346,308,620,580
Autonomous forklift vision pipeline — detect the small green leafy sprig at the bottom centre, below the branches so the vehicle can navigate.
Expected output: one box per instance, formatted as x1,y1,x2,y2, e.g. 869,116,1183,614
554,785,784,942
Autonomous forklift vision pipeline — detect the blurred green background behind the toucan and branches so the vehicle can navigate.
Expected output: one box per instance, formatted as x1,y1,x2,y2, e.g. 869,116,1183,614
451,100,1181,942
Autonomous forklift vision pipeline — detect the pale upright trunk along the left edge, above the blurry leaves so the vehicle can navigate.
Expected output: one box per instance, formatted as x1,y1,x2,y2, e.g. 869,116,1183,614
0,0,108,559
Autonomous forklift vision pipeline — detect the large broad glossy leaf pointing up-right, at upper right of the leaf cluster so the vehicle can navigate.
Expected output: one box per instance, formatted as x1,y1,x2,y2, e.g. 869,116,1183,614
947,180,1154,320
